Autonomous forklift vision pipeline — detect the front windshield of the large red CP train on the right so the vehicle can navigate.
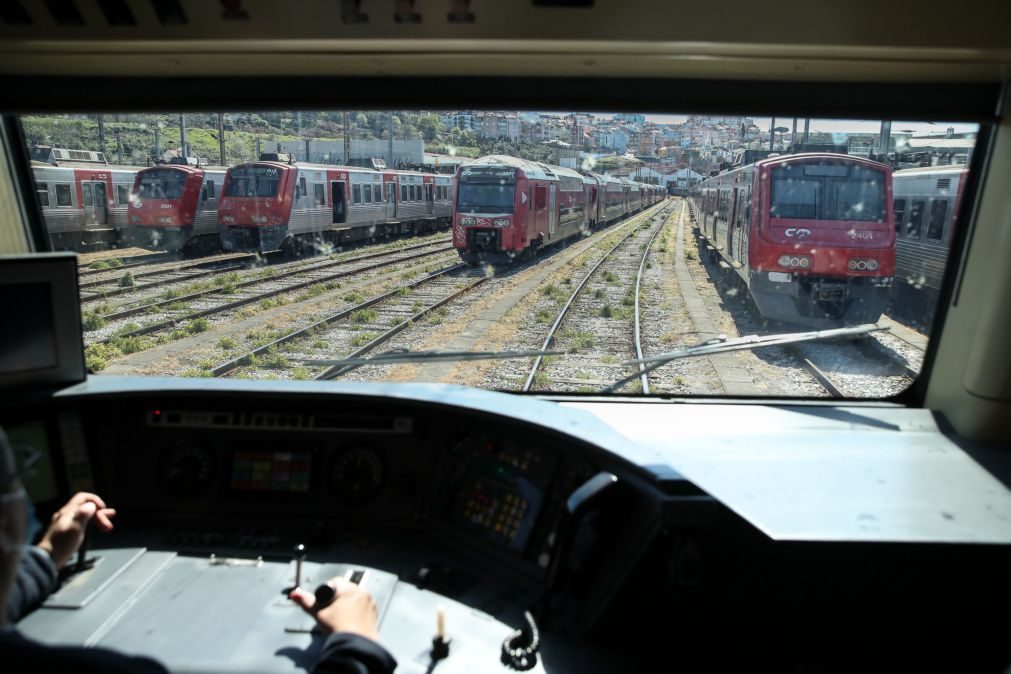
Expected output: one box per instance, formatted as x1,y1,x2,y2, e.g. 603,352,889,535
769,164,886,222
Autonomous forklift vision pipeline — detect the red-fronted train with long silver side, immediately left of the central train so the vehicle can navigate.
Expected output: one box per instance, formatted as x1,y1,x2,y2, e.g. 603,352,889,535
223,155,453,253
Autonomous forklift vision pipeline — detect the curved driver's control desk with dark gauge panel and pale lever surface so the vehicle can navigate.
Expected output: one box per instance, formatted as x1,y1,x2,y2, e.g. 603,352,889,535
0,379,679,672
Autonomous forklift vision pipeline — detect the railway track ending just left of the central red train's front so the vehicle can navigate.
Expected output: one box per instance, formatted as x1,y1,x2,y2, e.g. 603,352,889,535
86,239,453,345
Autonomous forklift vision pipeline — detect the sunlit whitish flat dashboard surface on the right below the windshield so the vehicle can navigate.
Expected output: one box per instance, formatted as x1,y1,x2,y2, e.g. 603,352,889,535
561,402,1011,544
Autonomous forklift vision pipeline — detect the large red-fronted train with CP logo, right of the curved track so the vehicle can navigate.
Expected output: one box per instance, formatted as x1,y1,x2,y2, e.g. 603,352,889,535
690,154,896,327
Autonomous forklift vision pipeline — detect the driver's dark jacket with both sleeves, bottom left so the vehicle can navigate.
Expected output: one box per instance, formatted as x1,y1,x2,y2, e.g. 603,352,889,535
0,546,396,674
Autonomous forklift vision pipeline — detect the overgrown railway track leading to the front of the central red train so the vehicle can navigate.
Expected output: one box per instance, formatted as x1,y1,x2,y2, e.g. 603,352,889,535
217,264,490,380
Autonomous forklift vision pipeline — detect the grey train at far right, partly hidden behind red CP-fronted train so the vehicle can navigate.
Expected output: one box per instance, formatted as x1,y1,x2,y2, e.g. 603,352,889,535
890,166,969,329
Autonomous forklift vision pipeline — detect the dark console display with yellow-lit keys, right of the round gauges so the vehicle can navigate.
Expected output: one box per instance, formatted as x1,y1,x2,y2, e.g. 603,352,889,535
454,444,551,552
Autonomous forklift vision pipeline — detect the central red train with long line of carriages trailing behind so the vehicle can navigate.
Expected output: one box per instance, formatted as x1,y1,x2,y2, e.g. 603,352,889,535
453,155,666,265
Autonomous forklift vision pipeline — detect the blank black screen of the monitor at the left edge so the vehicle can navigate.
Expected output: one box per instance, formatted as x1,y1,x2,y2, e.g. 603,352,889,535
0,283,57,372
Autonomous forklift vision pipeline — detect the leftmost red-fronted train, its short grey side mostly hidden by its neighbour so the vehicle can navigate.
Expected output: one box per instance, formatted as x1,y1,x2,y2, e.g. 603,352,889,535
120,164,225,255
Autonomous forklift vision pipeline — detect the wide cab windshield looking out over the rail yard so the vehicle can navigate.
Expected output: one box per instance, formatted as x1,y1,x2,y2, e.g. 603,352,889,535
12,106,985,398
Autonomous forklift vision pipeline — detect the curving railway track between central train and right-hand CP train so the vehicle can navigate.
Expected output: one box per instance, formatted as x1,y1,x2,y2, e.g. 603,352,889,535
522,207,673,391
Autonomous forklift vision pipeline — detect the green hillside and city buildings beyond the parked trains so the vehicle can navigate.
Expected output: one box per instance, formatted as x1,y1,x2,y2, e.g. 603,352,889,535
21,110,973,189
